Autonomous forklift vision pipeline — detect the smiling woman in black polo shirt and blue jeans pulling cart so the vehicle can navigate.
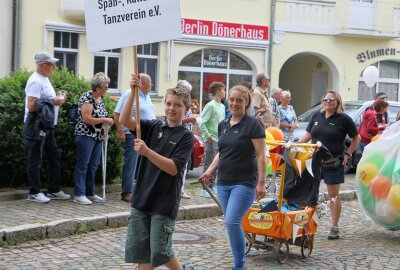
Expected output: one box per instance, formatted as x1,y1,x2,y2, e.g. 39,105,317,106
200,86,265,270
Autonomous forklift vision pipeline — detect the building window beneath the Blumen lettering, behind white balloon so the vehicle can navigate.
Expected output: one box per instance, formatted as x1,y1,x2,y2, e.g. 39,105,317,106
358,61,400,101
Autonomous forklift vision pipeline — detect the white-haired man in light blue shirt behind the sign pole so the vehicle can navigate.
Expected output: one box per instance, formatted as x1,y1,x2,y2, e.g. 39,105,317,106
114,73,156,202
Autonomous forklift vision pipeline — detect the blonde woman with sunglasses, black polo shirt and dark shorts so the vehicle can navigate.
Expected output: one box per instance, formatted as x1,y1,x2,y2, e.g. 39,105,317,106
299,90,360,240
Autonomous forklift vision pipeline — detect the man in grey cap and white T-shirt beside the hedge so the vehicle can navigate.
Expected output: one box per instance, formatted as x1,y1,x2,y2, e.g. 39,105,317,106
24,52,70,203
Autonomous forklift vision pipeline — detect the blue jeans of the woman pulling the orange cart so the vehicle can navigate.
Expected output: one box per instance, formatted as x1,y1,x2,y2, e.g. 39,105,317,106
217,185,256,270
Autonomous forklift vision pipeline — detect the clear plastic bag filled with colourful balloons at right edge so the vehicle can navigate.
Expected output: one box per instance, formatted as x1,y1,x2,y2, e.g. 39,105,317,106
356,121,400,230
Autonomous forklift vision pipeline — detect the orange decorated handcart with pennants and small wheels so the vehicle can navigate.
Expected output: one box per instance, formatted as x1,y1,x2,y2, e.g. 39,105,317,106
242,141,320,263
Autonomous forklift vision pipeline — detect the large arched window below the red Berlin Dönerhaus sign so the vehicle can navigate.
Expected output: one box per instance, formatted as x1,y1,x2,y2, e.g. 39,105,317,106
178,49,254,113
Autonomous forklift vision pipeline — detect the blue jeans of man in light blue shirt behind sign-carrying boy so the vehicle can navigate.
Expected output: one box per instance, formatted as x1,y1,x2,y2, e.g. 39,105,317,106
121,134,138,195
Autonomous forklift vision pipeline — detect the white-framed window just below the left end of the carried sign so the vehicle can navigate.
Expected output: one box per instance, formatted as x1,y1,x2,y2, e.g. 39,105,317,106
93,49,121,90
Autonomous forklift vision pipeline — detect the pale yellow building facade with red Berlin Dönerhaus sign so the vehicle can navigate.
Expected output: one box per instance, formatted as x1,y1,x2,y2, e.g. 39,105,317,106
10,0,400,115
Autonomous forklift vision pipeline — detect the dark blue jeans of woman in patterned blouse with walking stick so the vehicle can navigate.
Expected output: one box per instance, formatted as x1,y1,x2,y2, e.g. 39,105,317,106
74,136,102,196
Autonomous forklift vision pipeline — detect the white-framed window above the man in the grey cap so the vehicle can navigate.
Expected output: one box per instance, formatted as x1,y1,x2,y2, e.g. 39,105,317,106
54,31,79,74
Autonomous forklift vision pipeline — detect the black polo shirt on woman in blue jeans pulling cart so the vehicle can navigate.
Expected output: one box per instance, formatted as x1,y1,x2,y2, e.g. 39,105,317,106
218,116,265,187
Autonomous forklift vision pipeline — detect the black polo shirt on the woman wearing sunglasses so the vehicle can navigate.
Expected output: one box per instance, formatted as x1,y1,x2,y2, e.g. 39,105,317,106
306,112,358,156
